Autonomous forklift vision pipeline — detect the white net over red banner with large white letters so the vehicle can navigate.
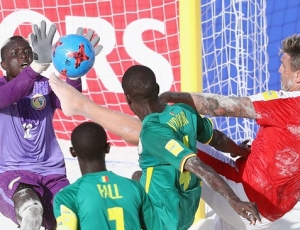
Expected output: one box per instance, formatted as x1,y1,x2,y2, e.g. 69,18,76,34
0,0,180,146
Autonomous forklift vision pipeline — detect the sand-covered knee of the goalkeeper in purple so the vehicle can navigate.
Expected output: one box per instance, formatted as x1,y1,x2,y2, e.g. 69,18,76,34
12,184,43,230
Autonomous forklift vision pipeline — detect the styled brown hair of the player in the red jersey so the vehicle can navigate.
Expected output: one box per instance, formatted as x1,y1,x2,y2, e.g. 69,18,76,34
280,34,300,71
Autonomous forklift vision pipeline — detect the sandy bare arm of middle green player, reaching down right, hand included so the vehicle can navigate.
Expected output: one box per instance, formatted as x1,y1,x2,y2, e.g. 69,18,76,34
184,156,261,225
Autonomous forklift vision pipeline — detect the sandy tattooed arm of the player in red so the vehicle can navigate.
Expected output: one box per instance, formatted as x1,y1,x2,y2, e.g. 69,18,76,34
159,92,256,119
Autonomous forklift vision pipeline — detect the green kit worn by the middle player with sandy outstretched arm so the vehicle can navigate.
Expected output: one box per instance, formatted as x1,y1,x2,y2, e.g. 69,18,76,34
139,104,213,229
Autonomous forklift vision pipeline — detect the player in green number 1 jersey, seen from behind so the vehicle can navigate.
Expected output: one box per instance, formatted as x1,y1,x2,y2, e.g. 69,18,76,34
54,122,163,230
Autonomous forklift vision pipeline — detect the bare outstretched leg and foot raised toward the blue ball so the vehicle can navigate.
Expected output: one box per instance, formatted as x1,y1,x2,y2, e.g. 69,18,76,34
49,73,142,145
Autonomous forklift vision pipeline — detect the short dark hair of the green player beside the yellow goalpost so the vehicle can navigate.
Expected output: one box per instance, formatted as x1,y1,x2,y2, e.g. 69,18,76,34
122,65,158,101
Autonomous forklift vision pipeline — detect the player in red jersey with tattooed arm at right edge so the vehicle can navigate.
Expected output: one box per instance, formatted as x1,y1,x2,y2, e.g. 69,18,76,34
161,35,300,230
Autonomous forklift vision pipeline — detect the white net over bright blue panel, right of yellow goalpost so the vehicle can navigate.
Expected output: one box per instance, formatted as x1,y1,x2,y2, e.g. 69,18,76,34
201,0,269,141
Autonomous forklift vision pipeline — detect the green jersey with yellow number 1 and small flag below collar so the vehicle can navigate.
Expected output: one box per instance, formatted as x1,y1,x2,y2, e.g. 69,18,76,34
54,171,164,230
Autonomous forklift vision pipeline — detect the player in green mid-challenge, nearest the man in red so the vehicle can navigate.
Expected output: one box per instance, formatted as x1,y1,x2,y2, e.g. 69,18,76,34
122,65,260,229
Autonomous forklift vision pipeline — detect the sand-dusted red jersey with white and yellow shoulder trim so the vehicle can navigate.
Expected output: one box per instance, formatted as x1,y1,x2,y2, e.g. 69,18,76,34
237,91,300,221
